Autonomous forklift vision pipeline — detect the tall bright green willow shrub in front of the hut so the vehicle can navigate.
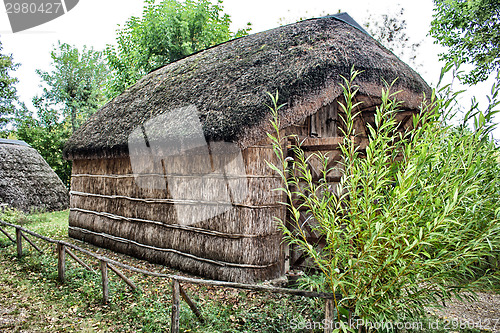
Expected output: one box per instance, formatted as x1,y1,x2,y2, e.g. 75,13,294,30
269,71,500,329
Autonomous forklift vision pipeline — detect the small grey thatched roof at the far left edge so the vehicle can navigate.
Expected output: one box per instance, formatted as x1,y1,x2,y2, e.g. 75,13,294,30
0,139,69,212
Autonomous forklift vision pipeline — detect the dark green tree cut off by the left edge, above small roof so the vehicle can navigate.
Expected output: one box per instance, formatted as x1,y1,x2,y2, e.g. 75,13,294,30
0,41,19,130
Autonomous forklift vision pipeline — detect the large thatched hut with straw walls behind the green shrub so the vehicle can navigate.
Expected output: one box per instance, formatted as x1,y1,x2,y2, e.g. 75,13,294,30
64,14,430,281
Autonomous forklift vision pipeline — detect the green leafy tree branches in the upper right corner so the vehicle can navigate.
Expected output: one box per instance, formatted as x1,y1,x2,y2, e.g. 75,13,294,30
430,0,500,84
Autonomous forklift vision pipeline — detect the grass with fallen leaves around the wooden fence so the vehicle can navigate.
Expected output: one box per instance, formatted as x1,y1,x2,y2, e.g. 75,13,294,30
0,211,488,332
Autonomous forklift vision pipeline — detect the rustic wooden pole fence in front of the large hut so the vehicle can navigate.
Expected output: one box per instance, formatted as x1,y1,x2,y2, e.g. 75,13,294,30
0,220,341,333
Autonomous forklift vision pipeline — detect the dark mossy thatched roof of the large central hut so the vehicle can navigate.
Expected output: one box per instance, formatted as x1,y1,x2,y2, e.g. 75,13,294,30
64,16,430,159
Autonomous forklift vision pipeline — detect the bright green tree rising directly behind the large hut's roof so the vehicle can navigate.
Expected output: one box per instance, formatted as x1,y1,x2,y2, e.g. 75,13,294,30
105,0,250,98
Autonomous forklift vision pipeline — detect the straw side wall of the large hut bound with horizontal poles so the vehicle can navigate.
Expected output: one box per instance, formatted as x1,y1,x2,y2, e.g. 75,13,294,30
69,146,284,282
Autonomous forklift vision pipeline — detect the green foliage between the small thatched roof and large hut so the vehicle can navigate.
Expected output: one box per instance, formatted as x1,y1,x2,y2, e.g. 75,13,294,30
14,42,108,184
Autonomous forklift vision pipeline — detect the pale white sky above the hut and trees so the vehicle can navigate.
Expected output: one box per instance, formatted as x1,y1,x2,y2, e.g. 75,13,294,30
0,0,500,139
